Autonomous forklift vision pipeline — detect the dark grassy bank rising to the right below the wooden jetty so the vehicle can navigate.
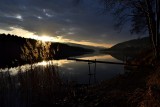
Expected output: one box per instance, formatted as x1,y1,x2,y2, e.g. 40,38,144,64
74,51,160,107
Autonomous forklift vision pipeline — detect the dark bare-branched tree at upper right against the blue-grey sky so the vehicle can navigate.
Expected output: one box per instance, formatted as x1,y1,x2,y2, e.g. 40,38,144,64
102,0,160,58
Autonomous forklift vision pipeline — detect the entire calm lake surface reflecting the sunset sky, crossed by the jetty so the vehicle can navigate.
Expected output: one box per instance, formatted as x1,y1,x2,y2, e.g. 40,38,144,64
0,55,124,83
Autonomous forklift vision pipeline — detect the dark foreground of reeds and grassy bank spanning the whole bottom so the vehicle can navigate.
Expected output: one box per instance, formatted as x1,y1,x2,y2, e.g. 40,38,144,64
0,49,160,107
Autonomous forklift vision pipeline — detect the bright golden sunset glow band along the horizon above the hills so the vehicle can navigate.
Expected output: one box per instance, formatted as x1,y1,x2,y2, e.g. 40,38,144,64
0,27,113,48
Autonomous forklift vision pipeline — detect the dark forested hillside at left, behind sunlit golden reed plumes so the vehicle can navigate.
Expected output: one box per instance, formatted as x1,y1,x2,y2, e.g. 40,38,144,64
0,34,93,67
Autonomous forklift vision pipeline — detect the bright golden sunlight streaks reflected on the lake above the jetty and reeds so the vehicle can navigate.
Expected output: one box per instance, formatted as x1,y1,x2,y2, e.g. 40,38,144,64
0,55,118,75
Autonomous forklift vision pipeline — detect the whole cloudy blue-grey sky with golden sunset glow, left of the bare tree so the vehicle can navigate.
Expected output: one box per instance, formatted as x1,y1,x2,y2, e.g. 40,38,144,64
0,0,140,47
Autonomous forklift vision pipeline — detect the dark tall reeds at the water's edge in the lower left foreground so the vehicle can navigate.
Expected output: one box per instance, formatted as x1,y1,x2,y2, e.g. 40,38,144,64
0,65,77,107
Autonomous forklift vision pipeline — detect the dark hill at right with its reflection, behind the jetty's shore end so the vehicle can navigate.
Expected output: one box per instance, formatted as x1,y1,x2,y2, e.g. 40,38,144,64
101,37,151,60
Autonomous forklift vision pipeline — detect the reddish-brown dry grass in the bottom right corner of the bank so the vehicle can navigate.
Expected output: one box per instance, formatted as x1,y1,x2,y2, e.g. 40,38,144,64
140,66,160,107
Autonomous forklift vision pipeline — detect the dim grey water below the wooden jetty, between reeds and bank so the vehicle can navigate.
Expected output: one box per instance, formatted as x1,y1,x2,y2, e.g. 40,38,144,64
59,62,123,83
